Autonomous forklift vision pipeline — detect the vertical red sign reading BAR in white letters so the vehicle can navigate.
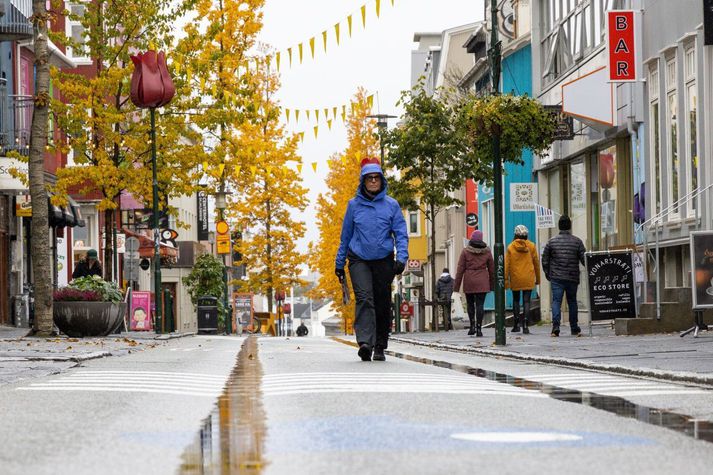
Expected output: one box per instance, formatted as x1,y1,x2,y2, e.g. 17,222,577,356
607,10,637,82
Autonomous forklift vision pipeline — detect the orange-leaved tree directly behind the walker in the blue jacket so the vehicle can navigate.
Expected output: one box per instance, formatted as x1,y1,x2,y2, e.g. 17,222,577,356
309,89,379,333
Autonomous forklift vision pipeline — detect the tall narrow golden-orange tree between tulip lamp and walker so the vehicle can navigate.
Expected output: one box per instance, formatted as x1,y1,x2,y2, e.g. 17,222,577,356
228,58,307,312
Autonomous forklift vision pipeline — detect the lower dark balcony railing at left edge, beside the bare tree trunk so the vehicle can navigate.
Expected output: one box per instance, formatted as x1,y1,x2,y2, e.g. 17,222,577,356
0,78,33,155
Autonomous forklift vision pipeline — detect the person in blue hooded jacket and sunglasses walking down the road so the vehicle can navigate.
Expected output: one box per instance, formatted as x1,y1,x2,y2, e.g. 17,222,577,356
334,158,408,361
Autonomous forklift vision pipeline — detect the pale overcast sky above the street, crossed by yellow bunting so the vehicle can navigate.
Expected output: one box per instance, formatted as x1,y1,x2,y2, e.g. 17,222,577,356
259,0,483,252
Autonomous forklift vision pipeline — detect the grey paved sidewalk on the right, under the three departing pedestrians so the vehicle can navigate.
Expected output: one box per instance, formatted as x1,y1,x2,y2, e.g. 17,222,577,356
391,325,713,386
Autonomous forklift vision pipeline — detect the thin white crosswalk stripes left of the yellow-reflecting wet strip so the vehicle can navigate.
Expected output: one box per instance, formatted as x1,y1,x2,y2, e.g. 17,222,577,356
17,371,225,398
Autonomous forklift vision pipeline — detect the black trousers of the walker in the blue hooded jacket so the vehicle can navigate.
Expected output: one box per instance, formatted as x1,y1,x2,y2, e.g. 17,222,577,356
348,253,394,348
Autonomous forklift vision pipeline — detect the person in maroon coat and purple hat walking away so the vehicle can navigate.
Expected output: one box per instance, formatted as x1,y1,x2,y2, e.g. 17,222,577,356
454,231,495,336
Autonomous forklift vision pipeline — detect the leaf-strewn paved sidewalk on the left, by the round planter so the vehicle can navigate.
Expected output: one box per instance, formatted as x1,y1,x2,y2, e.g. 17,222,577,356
0,326,190,385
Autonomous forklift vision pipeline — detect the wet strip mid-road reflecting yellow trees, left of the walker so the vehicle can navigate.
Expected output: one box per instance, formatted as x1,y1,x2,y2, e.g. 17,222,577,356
178,337,266,475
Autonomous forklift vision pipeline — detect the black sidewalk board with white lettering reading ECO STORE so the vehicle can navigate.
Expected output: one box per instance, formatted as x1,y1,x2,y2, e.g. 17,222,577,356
585,251,636,321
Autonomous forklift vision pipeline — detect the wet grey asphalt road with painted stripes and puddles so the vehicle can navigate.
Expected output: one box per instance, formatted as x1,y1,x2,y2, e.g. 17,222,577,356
0,337,713,475
